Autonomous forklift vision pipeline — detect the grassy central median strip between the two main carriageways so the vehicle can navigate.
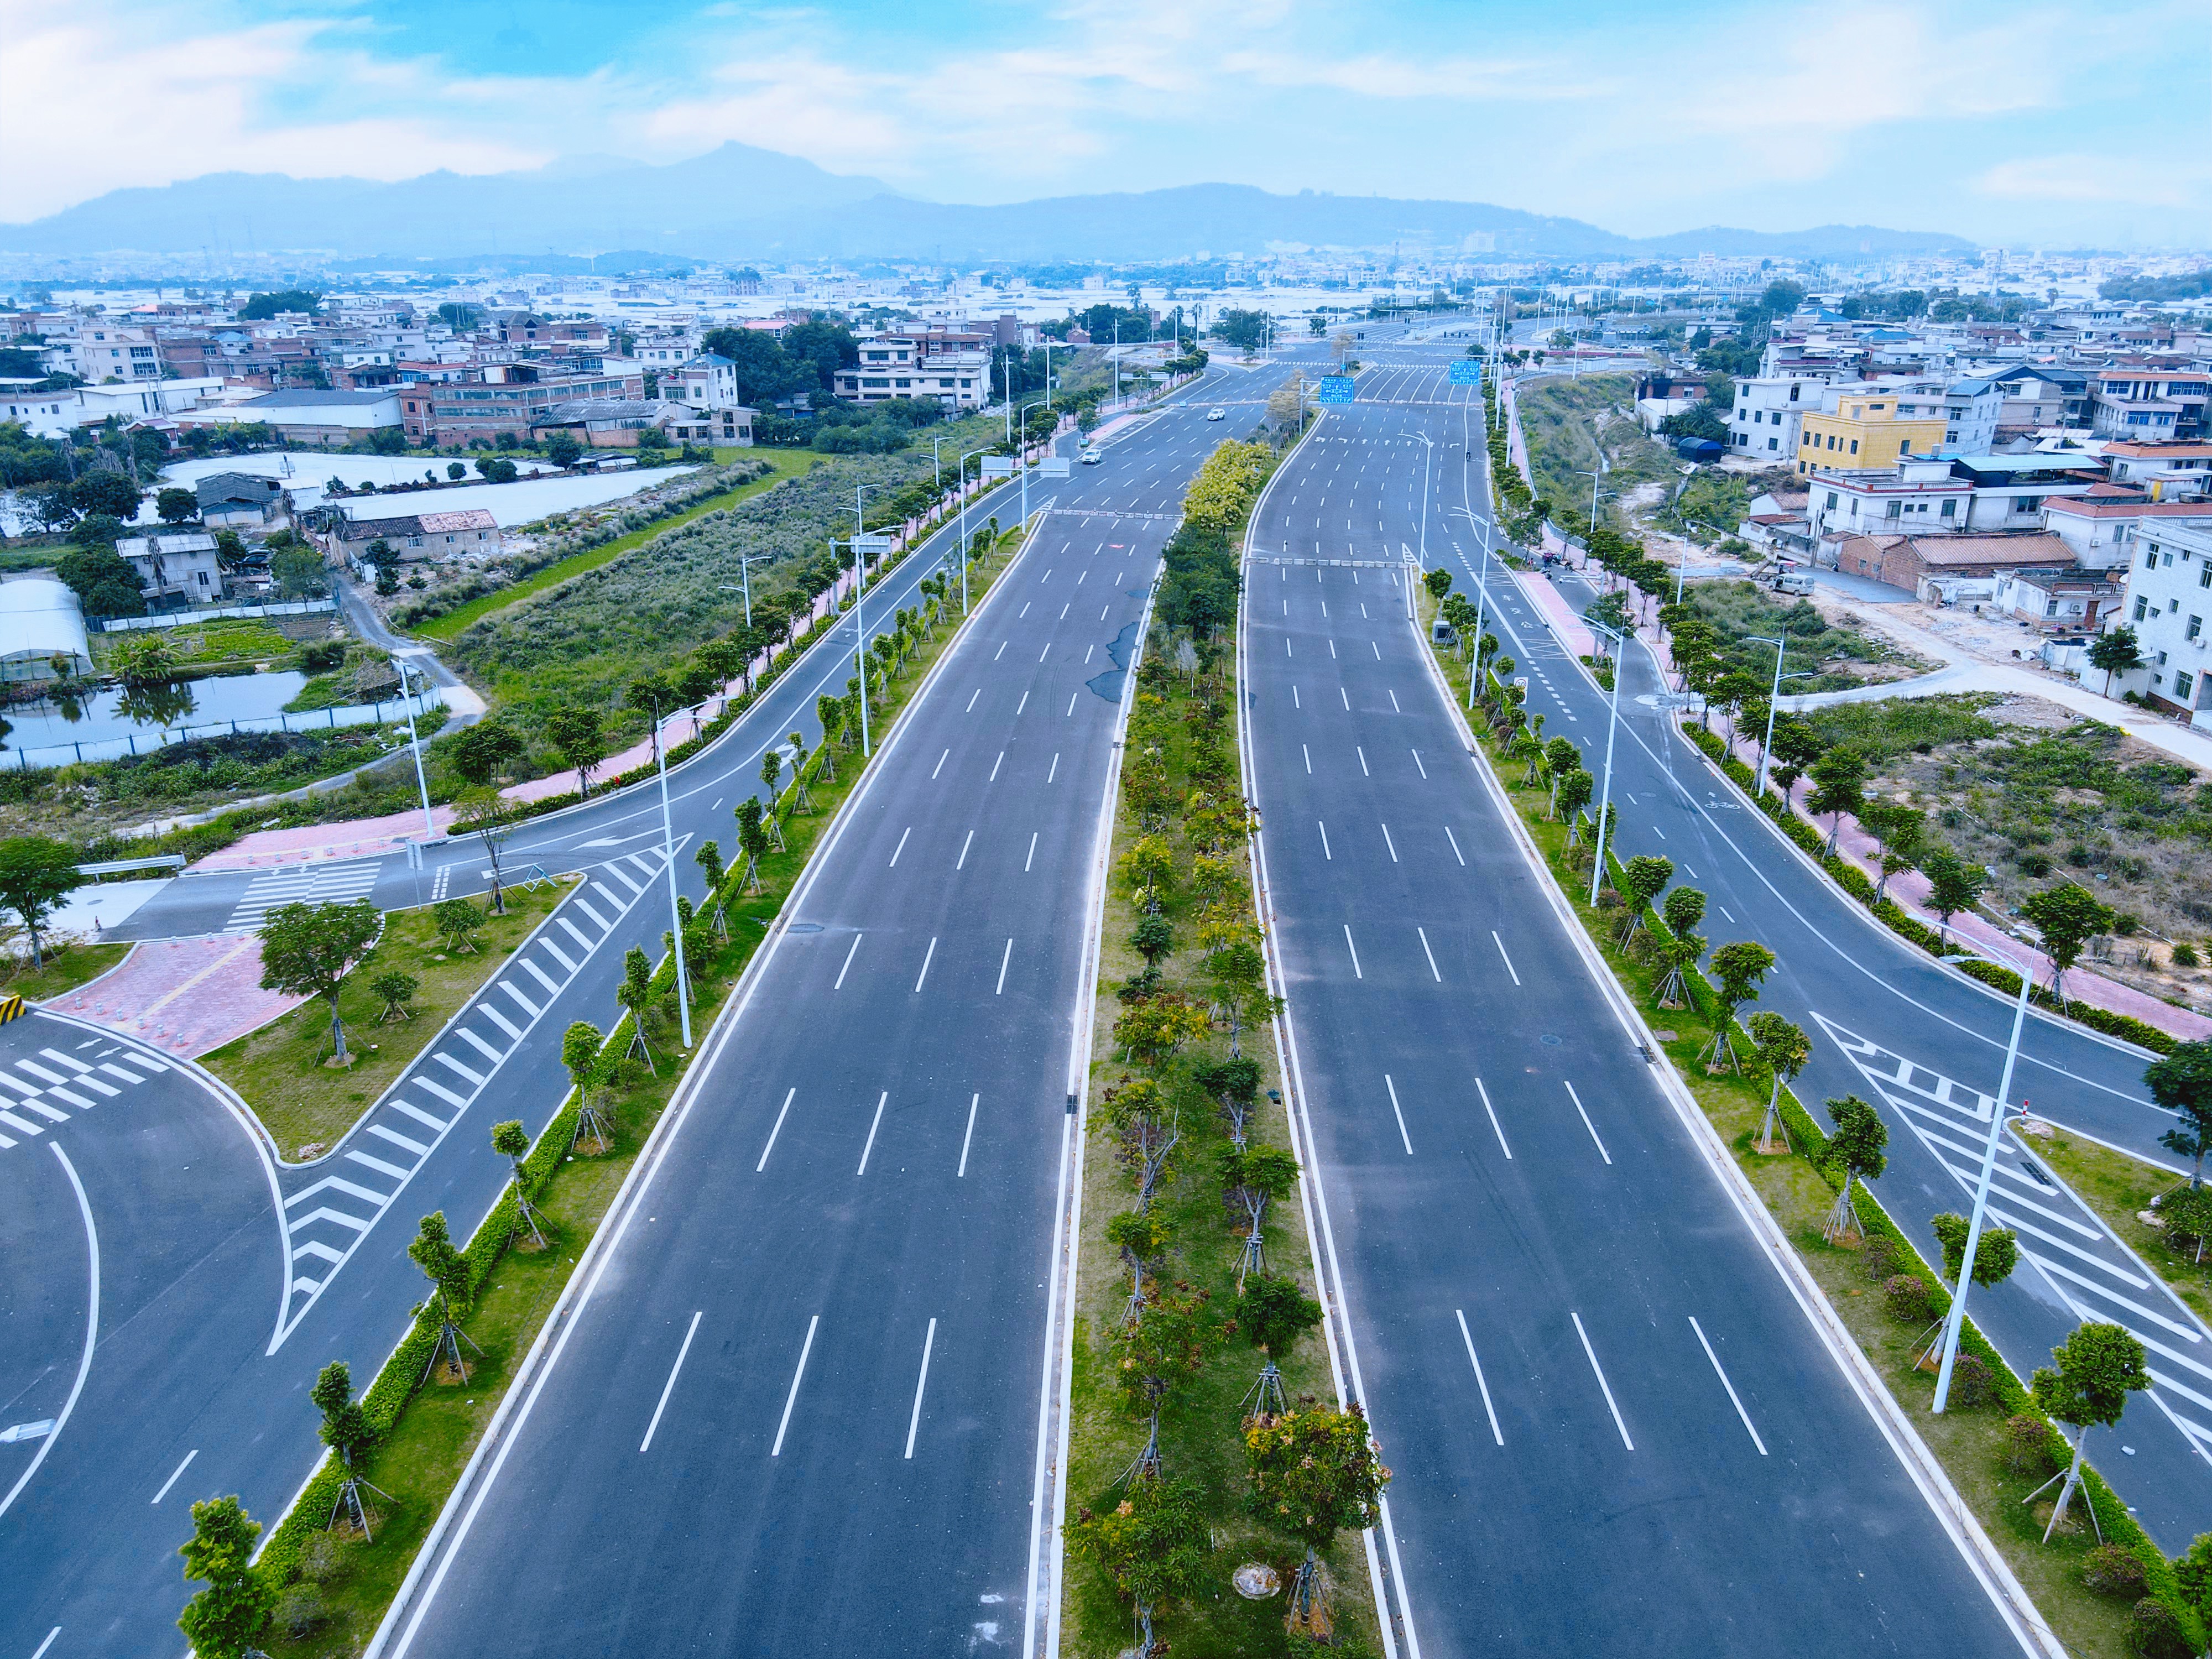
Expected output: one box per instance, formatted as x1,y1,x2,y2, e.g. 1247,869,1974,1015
1062,431,1378,1659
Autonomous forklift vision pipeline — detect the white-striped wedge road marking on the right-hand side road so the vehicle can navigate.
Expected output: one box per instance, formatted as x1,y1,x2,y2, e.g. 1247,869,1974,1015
1814,1013,2212,1462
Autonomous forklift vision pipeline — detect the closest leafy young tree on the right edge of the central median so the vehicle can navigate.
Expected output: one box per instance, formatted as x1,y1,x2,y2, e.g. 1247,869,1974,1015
1245,1402,1389,1641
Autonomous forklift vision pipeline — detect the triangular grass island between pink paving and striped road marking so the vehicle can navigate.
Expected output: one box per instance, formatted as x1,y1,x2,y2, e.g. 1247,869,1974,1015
199,876,580,1159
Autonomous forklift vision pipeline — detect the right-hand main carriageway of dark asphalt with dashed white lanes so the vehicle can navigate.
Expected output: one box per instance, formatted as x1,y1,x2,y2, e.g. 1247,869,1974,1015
1243,369,2022,1655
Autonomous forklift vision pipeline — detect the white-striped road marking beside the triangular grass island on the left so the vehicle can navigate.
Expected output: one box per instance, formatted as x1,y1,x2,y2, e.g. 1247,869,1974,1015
270,836,690,1354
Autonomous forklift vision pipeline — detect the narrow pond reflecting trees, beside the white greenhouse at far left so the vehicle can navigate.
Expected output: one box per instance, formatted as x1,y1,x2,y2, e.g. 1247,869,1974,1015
0,670,438,765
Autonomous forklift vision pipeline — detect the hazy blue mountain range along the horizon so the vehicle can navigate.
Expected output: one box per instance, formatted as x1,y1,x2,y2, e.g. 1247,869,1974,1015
0,144,1973,270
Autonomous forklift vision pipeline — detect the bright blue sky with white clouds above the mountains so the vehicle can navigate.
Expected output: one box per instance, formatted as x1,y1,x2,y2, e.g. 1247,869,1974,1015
0,0,2212,248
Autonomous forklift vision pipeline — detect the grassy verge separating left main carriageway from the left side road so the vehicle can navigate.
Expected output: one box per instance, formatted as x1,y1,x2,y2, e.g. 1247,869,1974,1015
247,513,1040,1659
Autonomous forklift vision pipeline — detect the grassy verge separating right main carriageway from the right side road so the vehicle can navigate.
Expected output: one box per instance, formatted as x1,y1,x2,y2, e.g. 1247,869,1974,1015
1425,584,2201,1657
